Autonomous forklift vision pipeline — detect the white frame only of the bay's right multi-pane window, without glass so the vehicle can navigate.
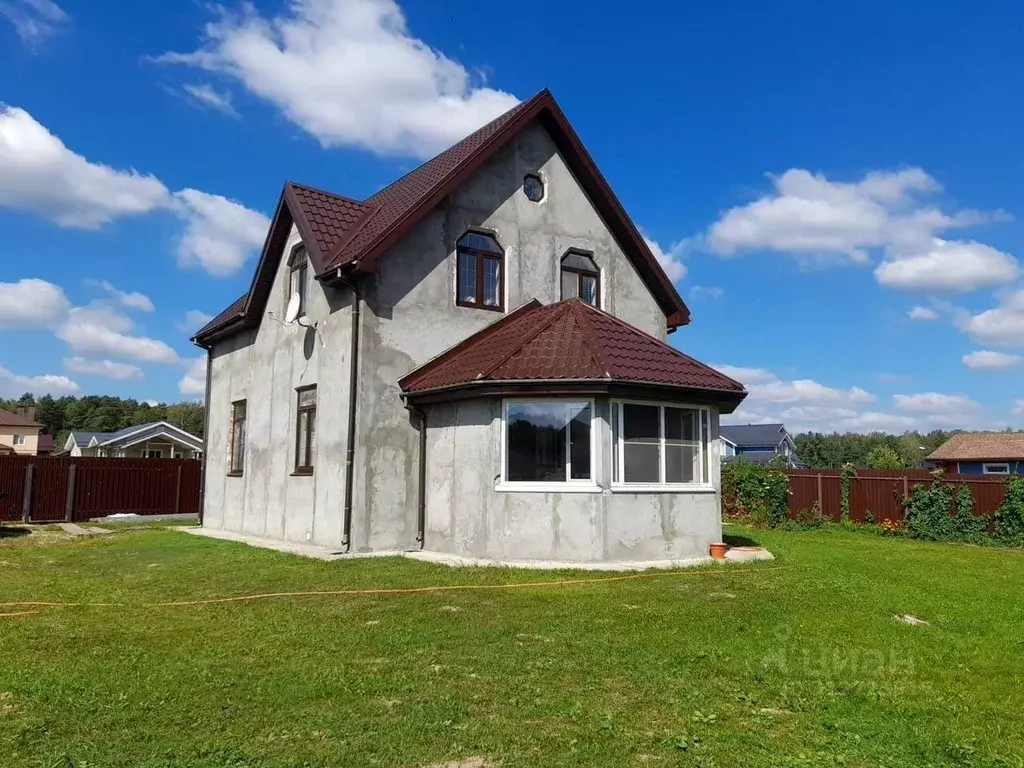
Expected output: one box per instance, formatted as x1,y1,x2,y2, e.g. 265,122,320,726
608,397,715,493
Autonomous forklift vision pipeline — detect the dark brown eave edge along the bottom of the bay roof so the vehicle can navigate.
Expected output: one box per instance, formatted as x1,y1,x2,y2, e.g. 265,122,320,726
402,379,746,414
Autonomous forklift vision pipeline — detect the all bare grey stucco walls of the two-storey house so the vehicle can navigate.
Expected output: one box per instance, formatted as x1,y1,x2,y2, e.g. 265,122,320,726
204,118,721,562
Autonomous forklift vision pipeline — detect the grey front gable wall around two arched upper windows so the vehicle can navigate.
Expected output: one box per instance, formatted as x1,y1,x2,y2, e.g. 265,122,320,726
353,118,667,550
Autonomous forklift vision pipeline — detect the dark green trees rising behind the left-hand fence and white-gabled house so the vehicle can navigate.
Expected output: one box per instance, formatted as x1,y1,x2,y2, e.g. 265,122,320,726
0,393,205,451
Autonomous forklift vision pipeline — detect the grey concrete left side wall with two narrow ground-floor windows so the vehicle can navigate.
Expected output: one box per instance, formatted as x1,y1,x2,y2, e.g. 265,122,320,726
204,229,351,547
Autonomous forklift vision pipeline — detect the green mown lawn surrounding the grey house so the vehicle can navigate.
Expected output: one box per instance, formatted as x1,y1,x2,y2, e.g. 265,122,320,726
0,528,1024,768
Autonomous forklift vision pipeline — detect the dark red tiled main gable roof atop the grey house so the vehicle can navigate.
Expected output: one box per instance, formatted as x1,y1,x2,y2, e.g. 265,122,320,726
193,89,690,345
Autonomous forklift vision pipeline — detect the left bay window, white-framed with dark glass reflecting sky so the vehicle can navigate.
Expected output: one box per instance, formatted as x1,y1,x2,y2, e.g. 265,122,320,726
502,400,595,486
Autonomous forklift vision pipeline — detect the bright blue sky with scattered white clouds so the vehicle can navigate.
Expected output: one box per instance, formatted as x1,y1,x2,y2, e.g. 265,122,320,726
0,0,1024,431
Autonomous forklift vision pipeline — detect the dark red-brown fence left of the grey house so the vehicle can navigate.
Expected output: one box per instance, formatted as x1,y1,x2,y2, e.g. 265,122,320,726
0,457,203,522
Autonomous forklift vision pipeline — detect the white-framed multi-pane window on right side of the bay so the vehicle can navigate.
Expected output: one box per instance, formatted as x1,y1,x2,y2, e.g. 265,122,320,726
611,401,711,485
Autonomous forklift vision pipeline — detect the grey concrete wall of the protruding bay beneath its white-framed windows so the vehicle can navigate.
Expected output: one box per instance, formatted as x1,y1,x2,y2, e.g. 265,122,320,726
424,398,722,562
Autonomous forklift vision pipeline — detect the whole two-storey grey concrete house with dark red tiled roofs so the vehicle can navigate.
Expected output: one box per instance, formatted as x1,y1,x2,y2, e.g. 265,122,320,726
194,91,745,562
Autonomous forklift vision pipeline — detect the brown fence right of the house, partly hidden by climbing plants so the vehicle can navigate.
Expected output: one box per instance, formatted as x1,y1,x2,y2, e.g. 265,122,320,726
786,469,1006,522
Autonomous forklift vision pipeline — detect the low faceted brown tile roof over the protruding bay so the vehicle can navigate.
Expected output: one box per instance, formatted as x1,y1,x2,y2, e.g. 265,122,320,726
399,299,743,394
